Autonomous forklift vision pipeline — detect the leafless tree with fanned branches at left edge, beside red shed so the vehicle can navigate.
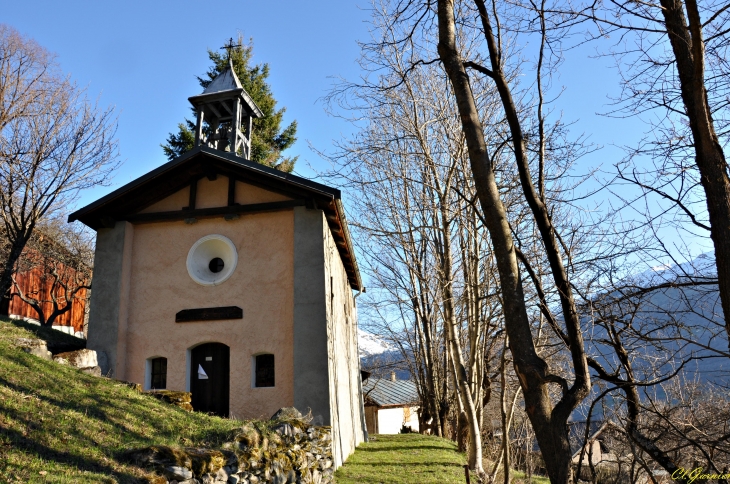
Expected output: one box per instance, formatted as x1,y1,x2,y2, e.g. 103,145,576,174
0,24,118,306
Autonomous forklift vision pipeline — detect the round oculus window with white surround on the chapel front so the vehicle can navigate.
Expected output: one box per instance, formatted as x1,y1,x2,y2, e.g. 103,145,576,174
187,234,238,286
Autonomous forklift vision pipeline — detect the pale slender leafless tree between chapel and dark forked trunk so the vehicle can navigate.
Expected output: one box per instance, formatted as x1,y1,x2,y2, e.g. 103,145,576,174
322,17,509,466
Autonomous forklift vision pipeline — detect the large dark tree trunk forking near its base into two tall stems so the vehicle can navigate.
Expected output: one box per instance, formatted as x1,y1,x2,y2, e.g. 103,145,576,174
438,0,590,483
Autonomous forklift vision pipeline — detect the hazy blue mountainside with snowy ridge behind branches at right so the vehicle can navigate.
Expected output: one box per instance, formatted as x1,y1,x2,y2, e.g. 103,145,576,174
584,252,730,386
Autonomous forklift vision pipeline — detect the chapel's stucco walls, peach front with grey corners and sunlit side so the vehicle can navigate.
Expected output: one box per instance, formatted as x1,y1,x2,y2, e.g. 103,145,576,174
84,176,365,467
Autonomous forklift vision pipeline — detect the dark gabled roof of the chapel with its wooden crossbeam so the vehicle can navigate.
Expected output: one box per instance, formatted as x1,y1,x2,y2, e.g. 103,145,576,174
68,146,363,290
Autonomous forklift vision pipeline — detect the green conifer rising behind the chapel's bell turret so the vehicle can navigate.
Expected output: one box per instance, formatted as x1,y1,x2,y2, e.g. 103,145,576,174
161,34,297,173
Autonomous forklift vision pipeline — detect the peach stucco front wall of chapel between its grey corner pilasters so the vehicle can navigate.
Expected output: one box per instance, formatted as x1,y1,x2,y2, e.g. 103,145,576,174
124,211,293,418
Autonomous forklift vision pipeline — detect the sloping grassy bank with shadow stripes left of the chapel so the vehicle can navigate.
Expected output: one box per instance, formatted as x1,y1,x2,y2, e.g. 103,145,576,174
0,318,240,483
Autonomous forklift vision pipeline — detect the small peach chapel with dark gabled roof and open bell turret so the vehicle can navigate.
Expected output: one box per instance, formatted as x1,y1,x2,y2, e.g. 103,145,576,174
69,58,365,466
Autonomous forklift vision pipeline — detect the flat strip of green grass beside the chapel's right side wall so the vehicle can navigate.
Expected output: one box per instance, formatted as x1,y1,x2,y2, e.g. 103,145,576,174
335,434,466,484
